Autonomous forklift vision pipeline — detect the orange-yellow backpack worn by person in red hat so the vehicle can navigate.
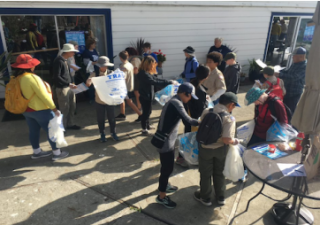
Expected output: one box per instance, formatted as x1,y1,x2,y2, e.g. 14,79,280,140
4,74,35,114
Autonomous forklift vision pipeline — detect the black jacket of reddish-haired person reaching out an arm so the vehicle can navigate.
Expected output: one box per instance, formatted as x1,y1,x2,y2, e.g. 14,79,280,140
137,70,172,101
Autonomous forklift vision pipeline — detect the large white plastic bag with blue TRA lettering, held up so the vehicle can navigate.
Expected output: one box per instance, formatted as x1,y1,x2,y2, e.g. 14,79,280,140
92,69,128,105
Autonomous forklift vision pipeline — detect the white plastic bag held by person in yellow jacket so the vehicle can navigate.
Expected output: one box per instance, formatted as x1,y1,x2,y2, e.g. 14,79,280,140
48,114,68,148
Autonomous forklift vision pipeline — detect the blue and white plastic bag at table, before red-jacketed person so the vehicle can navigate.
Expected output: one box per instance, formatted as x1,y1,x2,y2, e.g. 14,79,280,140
267,121,298,142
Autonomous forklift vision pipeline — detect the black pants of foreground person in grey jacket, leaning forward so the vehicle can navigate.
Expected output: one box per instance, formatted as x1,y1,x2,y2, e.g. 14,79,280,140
158,151,174,192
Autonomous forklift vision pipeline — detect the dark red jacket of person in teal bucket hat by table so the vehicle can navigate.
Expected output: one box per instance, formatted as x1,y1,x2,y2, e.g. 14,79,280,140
253,93,288,139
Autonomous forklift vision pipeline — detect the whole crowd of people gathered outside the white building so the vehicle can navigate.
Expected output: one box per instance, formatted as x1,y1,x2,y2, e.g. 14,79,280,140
8,35,306,208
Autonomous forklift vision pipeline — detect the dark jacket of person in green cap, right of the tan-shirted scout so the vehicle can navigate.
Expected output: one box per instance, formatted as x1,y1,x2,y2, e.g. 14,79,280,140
223,63,241,94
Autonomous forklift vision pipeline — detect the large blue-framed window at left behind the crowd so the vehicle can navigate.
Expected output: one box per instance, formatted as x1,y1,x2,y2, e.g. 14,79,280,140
0,15,107,84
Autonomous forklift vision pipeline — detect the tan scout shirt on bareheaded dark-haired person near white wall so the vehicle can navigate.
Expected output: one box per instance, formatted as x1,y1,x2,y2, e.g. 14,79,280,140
203,68,227,97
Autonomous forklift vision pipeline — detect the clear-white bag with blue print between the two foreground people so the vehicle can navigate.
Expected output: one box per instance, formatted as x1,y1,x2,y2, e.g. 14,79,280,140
178,132,199,165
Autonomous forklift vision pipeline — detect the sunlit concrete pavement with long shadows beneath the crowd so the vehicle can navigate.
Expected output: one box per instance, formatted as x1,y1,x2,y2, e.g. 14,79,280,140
0,87,320,225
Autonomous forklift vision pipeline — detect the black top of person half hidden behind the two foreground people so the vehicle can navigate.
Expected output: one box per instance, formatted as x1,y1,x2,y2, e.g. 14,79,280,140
187,85,208,119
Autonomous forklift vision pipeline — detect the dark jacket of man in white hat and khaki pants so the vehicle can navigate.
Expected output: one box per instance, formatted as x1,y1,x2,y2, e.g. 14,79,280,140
52,56,73,88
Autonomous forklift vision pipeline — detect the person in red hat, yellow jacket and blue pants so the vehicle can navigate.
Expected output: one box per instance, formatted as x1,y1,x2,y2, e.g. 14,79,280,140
11,54,69,161
